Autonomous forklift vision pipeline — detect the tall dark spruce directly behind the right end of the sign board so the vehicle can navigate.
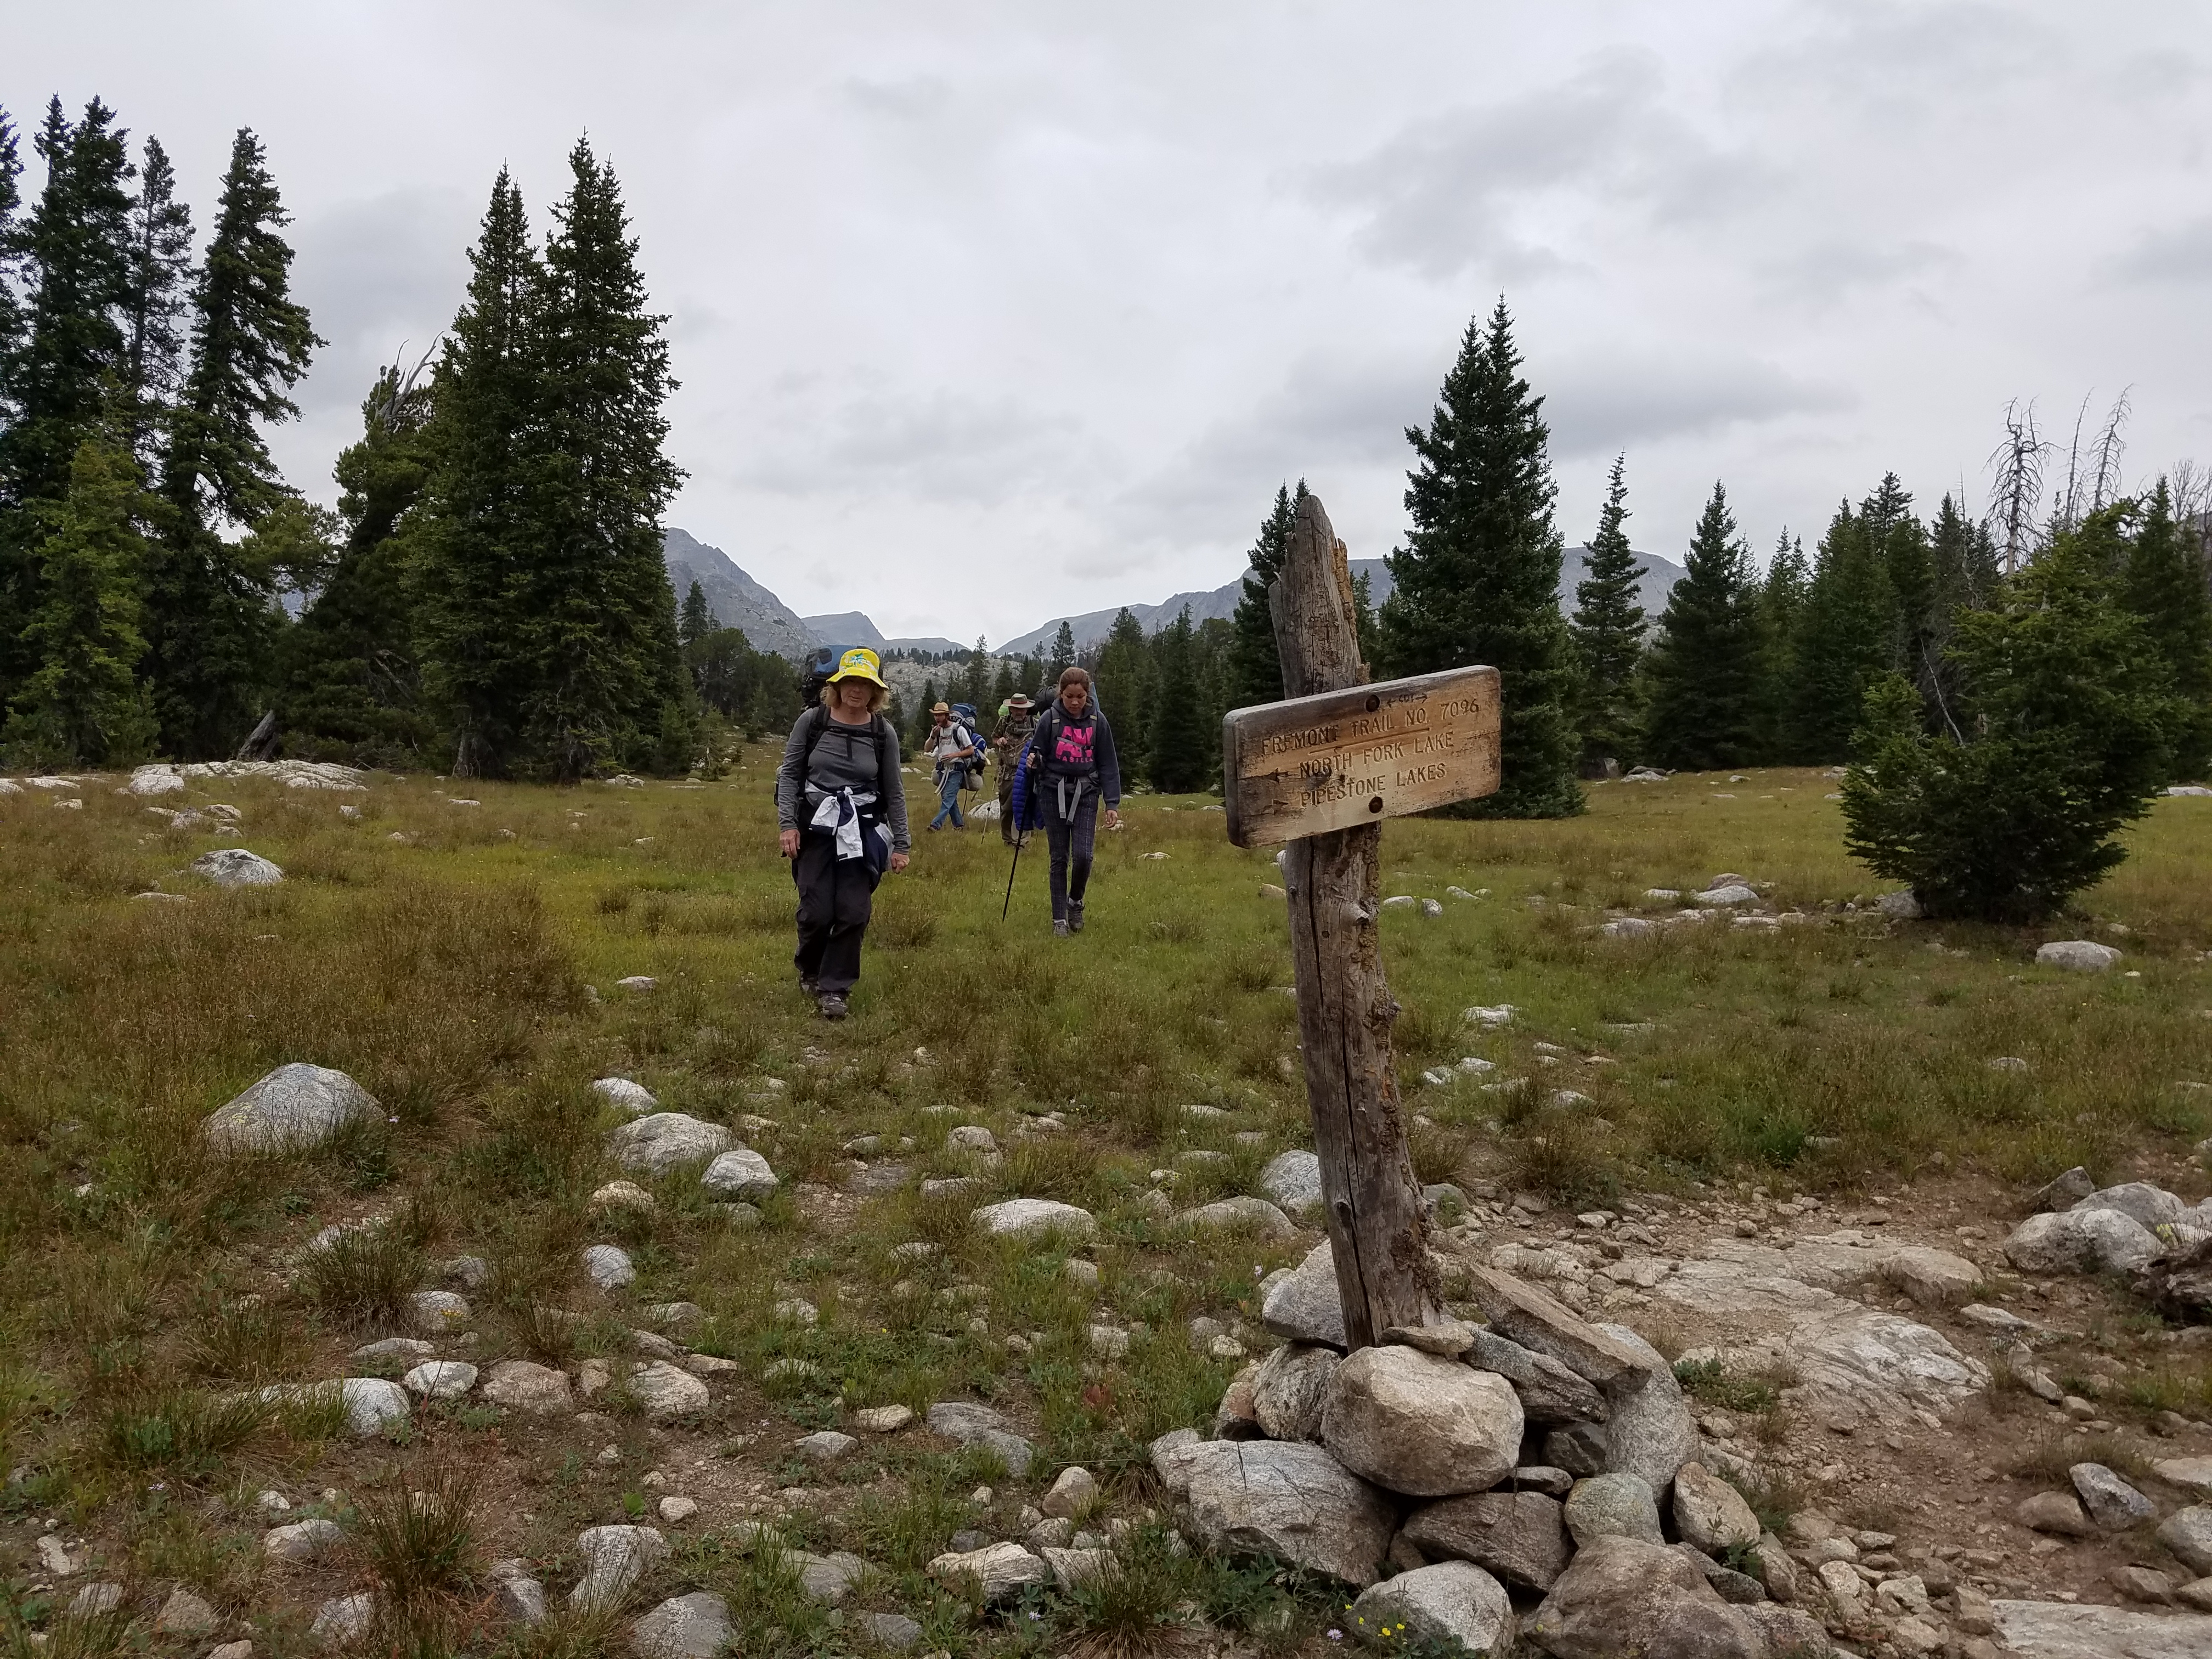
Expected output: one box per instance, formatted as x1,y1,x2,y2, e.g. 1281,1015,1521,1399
1378,298,1582,819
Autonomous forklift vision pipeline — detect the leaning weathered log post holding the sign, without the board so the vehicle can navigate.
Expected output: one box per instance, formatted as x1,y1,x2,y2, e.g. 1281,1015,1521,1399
1267,495,1442,1350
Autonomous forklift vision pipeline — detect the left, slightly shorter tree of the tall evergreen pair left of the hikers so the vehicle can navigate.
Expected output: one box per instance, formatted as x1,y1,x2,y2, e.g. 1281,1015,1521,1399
407,168,546,778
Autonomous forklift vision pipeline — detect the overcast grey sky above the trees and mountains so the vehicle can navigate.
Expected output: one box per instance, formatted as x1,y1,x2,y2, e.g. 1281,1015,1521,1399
17,0,2212,639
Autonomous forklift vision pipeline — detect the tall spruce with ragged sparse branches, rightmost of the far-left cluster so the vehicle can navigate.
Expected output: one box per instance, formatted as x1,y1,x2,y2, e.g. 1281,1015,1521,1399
150,128,321,757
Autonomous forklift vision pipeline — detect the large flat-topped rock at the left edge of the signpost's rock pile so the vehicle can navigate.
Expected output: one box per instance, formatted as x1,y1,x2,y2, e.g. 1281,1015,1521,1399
1153,1436,1396,1586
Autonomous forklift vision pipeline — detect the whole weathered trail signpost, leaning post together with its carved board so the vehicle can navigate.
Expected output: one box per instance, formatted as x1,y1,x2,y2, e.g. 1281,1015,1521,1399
1221,495,1498,1350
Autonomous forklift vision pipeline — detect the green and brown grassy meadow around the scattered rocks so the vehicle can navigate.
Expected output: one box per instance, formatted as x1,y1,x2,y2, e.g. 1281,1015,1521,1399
0,748,2212,1655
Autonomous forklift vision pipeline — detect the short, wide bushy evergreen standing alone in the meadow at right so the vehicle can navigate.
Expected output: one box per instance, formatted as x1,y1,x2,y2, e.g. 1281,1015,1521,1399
1843,502,2181,922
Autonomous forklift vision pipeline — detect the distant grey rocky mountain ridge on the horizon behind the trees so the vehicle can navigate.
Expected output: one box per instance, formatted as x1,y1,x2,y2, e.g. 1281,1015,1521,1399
662,529,1683,662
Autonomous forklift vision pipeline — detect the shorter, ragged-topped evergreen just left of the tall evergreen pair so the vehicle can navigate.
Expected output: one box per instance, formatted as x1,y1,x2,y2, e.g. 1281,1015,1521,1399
279,365,438,770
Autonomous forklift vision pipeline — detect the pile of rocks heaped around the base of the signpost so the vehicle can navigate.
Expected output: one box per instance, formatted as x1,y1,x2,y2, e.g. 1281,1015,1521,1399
1153,1243,1831,1659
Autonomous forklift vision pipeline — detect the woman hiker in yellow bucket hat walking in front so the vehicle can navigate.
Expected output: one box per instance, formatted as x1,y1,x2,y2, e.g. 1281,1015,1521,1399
776,648,911,1020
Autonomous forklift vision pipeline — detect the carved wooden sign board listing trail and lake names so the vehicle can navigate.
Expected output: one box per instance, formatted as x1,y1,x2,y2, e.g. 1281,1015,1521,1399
1221,668,1498,847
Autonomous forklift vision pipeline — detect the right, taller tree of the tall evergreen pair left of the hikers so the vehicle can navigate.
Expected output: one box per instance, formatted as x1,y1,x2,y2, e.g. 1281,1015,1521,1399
511,139,688,783
